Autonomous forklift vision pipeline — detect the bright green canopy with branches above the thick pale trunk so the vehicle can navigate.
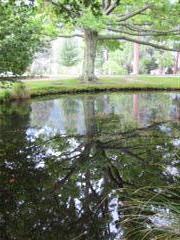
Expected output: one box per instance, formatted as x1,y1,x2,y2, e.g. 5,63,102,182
48,0,180,48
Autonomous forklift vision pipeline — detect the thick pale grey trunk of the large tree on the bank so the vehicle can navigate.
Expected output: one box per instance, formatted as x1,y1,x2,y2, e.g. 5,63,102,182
82,29,97,82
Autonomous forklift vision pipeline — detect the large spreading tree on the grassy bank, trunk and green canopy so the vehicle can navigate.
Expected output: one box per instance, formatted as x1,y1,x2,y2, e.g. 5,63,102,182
45,0,180,81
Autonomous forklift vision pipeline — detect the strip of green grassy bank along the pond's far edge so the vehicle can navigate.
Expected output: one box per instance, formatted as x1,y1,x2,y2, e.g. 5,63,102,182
0,76,180,101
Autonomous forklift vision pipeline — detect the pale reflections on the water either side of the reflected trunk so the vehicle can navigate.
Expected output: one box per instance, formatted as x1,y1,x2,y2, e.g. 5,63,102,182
27,93,180,141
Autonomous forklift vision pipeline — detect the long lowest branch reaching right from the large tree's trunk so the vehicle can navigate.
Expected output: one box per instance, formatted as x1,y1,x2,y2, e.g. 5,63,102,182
98,35,180,52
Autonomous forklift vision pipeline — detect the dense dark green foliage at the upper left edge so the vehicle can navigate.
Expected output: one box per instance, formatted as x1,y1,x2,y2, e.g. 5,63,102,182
0,3,44,75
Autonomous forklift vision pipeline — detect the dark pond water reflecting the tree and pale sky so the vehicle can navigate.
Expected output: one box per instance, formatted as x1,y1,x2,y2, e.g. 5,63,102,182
0,92,180,240
